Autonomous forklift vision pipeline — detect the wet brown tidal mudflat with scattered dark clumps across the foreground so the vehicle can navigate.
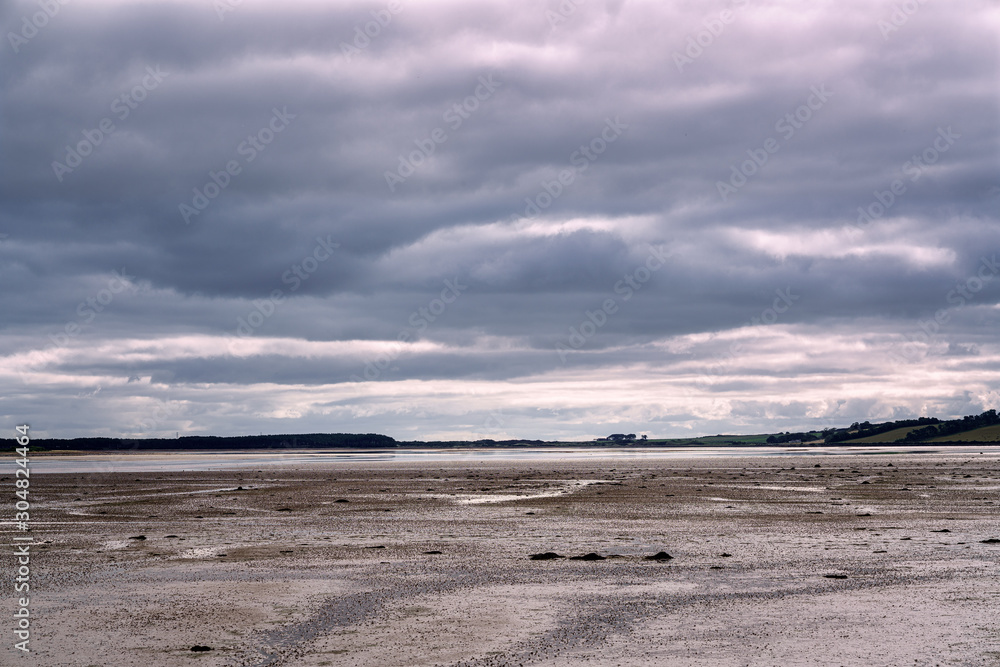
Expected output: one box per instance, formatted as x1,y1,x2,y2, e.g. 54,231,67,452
7,453,1000,667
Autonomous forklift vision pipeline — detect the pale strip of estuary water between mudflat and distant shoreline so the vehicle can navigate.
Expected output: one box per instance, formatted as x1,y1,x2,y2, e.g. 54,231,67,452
15,445,1000,474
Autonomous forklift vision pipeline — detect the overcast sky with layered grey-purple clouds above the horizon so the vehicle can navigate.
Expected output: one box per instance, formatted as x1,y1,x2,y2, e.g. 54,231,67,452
0,0,1000,440
